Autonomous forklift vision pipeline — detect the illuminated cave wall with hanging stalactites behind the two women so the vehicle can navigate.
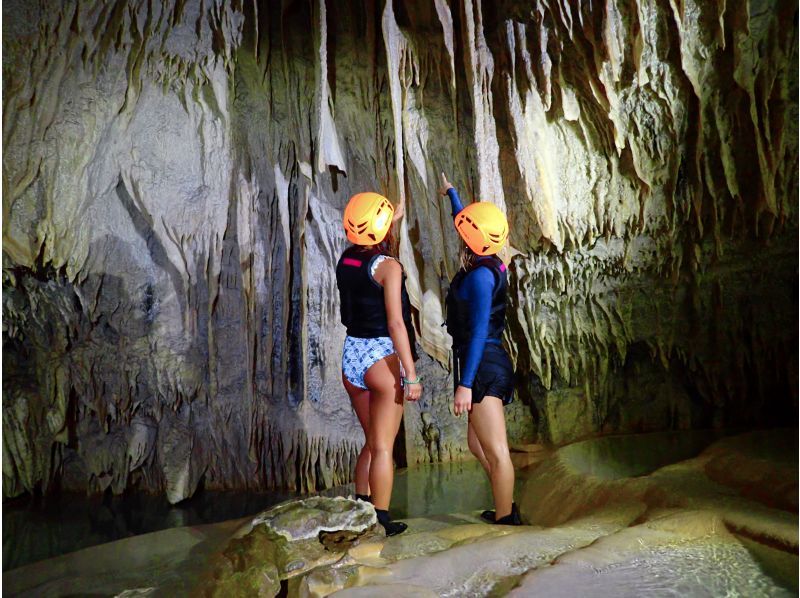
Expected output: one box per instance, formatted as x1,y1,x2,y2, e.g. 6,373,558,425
3,0,798,502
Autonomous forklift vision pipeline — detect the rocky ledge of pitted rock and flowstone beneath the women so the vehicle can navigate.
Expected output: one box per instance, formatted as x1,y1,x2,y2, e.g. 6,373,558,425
202,431,798,597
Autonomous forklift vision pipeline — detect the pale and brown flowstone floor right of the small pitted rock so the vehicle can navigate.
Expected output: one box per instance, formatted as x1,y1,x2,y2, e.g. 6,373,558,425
290,430,798,598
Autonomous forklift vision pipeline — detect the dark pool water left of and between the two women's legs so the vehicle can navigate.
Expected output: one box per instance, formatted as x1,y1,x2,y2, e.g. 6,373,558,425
3,462,491,571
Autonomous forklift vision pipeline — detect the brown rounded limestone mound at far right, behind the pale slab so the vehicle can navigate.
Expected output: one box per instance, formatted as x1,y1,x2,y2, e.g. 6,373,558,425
520,430,798,552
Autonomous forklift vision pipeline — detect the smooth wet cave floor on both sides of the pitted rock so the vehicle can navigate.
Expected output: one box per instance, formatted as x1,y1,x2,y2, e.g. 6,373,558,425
3,430,798,597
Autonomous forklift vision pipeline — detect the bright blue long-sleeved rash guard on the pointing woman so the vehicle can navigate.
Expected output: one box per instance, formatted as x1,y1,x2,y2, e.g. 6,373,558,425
447,187,498,388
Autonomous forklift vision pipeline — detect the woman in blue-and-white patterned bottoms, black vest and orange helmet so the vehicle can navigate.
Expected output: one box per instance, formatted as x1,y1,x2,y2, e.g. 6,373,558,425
336,193,422,536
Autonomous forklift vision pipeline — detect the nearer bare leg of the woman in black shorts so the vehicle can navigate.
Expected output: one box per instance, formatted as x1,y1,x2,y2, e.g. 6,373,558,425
470,397,514,519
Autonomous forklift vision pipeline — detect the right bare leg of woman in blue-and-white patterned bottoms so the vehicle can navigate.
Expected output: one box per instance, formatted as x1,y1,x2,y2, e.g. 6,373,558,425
364,355,403,510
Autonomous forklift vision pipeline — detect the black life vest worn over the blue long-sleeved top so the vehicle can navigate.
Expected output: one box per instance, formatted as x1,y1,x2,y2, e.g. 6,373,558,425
445,255,508,348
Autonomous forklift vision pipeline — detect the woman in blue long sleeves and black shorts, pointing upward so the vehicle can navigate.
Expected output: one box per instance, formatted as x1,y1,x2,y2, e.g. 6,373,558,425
440,173,522,525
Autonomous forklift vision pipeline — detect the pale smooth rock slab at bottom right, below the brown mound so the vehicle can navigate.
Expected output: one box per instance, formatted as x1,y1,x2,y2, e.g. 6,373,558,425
509,511,797,598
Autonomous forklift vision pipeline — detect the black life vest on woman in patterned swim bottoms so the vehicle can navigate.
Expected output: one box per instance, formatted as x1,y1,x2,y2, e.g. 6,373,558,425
336,245,417,360
